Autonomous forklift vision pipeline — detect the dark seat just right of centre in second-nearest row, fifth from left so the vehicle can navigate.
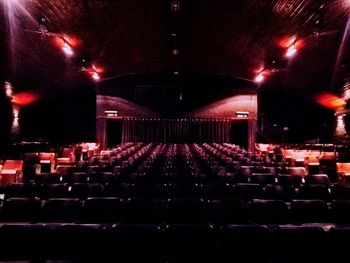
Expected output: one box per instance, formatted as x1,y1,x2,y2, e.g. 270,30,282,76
165,199,206,224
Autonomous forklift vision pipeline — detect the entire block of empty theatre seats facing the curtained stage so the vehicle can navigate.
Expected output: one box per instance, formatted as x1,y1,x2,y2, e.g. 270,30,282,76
0,143,350,263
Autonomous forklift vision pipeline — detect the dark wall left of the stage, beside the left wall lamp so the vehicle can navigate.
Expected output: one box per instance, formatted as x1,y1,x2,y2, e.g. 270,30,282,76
20,89,96,143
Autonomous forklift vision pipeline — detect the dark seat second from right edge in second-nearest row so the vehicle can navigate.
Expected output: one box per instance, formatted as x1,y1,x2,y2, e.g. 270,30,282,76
291,200,330,224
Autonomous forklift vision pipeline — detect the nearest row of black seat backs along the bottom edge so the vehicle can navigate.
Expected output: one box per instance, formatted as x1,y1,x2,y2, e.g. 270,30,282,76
0,224,350,263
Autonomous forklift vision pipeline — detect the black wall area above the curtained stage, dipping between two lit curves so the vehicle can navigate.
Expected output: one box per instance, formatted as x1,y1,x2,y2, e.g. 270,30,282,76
97,73,256,117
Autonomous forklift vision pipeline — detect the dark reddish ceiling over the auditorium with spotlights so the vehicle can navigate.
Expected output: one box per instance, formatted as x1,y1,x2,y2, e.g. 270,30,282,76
0,0,349,95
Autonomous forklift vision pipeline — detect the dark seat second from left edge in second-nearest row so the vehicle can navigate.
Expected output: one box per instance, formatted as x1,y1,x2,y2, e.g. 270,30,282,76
43,198,82,223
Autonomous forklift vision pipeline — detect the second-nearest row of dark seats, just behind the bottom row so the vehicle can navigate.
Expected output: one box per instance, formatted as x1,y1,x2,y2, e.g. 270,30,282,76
0,197,350,225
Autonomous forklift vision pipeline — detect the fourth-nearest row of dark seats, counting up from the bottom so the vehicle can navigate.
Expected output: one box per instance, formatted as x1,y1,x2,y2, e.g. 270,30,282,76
30,166,330,186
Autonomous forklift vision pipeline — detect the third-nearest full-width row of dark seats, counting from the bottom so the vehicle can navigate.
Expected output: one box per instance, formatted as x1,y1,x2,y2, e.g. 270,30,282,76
1,183,350,201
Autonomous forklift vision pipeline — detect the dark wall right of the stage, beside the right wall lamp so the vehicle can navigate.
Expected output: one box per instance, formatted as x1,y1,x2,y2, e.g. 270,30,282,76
258,86,335,143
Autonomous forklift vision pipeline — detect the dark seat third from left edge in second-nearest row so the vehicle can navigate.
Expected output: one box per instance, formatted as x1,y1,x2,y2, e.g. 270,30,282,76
82,197,124,223
